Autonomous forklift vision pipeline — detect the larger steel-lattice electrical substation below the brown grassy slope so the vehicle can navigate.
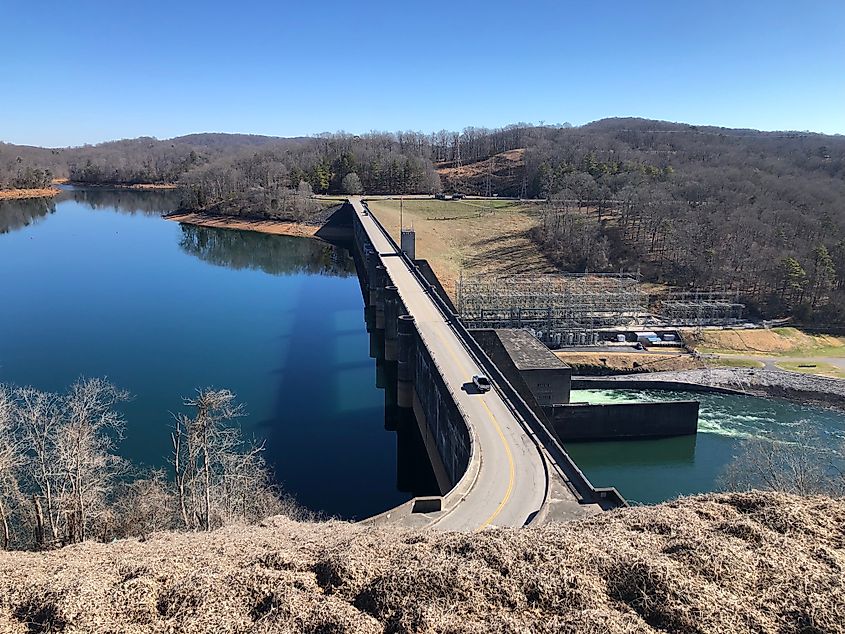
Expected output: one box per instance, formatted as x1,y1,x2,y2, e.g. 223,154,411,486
457,273,648,346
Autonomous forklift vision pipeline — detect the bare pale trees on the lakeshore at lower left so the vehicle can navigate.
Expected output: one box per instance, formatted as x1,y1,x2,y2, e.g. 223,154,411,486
0,379,299,550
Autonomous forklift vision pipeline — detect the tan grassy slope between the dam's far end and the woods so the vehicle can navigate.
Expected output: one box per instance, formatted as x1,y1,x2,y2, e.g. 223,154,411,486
368,199,555,298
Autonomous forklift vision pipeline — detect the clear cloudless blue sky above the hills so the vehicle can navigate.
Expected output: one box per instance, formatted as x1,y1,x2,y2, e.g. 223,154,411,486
0,0,845,146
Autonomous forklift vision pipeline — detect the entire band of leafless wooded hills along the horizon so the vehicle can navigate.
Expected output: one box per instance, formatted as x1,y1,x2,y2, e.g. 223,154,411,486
0,119,845,324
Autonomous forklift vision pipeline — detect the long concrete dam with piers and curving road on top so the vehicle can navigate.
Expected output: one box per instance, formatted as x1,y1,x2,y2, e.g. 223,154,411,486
318,197,625,531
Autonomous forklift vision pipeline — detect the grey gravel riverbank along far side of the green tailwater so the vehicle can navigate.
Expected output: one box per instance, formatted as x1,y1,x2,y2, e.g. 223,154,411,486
581,368,845,411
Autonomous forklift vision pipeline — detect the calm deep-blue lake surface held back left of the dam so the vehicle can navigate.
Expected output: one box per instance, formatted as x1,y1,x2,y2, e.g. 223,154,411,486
0,190,431,518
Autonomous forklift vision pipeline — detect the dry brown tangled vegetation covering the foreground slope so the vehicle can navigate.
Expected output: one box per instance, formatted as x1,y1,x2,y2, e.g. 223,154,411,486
0,492,845,633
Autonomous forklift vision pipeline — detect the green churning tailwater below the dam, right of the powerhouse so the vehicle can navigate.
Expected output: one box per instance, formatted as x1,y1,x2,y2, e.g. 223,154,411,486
566,390,845,503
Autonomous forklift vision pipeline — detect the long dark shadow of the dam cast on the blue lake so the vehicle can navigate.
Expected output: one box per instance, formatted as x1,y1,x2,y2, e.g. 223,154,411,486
266,241,438,519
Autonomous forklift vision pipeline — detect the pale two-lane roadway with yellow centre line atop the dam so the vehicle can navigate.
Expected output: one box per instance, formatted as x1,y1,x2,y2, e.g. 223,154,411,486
349,197,586,531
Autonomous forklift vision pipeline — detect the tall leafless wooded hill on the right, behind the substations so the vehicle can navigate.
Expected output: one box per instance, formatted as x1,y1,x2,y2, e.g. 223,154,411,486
474,119,845,324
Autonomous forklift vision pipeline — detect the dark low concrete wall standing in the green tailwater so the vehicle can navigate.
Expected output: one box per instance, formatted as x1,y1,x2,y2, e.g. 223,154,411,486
543,401,698,442
